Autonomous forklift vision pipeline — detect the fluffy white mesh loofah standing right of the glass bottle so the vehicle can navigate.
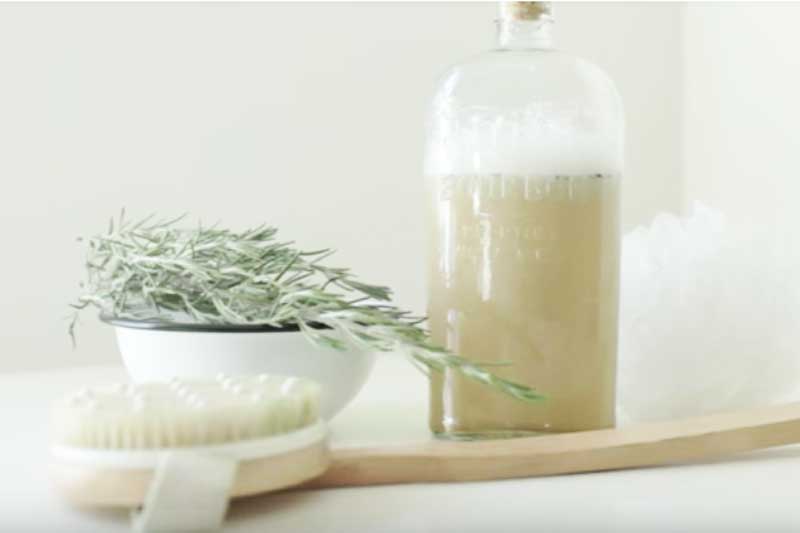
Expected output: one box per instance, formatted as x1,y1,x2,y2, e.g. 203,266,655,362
619,205,800,422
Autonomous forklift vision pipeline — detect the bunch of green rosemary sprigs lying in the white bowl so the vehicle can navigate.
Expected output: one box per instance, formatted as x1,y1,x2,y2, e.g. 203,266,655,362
70,212,543,402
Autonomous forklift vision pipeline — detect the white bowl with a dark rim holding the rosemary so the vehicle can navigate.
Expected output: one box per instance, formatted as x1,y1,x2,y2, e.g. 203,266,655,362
106,319,375,420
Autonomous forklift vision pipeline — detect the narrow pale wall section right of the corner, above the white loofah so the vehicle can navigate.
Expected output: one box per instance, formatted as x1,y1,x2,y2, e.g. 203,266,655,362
683,2,800,227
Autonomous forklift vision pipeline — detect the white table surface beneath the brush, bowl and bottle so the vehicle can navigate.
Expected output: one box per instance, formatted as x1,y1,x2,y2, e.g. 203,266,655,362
0,358,800,533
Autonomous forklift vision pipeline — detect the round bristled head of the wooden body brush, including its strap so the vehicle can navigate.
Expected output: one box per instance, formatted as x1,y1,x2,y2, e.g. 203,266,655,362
51,375,329,532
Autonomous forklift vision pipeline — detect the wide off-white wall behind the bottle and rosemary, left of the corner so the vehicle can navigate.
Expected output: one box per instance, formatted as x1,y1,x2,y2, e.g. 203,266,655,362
0,3,688,370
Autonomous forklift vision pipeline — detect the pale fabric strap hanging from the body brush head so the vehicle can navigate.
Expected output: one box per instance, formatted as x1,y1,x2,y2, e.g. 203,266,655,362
132,451,238,533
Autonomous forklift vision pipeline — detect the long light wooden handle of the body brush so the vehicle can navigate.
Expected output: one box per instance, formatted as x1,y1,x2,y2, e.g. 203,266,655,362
307,403,800,488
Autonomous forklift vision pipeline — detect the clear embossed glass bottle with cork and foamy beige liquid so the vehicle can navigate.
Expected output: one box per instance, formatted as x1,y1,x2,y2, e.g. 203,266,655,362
425,2,623,438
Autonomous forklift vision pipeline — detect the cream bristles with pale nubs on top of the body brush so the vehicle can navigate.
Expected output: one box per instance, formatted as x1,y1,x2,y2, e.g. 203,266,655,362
53,375,320,450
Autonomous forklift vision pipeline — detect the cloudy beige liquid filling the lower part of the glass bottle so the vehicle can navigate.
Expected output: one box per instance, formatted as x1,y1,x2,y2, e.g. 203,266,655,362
428,174,619,438
